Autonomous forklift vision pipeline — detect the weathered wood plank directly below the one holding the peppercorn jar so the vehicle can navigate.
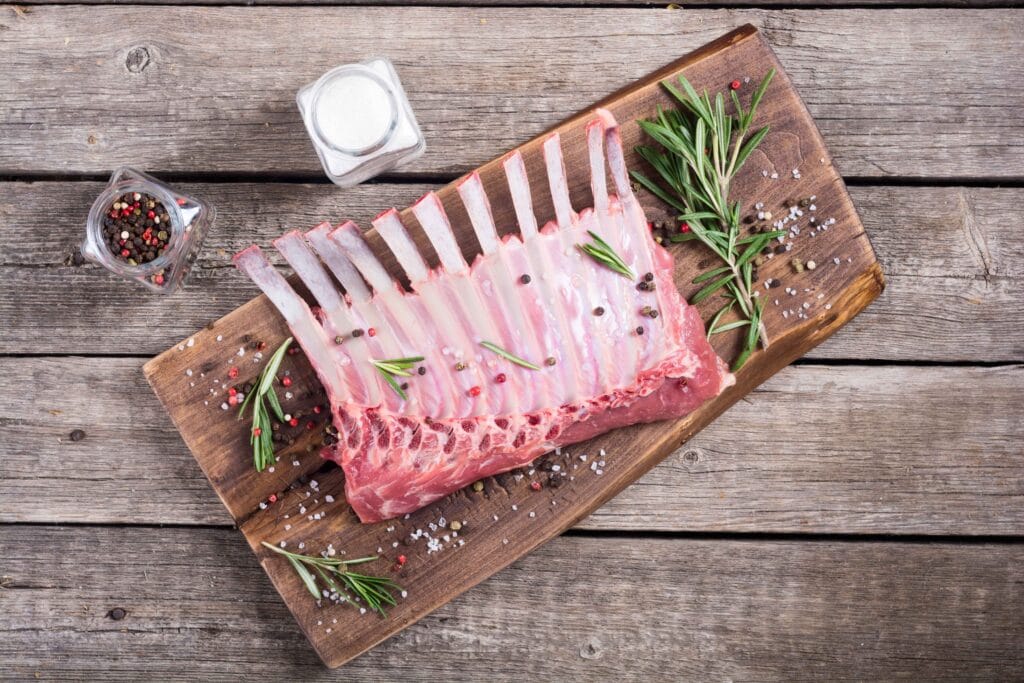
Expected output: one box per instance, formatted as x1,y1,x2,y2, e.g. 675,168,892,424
0,357,1024,535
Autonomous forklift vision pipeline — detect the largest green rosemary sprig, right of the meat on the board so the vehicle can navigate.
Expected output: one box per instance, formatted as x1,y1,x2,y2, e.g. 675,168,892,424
632,69,784,371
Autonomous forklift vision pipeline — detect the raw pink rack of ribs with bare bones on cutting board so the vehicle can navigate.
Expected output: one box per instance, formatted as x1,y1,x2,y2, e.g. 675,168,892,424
236,110,733,522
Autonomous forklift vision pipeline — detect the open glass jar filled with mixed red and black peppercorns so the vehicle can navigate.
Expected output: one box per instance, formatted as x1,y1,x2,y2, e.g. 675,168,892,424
82,167,216,294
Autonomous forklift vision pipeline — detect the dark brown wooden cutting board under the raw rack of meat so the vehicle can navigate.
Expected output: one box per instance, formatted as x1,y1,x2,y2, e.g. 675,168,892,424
144,26,884,667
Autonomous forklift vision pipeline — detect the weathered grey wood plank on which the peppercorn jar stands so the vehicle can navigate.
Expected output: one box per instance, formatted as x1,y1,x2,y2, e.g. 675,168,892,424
0,182,1024,361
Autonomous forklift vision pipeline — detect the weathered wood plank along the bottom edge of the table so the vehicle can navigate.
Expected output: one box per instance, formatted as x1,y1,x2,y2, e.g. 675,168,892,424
0,526,1024,681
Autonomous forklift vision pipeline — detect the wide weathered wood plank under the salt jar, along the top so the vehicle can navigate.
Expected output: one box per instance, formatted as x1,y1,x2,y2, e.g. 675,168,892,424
0,5,1024,178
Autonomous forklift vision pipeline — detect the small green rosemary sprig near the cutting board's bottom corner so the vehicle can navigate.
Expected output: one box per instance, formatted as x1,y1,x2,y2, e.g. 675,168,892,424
263,541,401,616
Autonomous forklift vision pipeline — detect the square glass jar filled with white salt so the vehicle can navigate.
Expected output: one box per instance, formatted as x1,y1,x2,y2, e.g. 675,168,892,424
296,57,426,187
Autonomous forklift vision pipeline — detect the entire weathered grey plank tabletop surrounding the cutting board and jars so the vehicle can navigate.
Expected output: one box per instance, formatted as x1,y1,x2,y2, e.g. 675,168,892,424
0,0,1024,681
